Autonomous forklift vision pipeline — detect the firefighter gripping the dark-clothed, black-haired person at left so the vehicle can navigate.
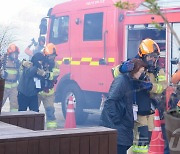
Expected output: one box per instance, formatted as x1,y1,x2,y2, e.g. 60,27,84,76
38,43,60,129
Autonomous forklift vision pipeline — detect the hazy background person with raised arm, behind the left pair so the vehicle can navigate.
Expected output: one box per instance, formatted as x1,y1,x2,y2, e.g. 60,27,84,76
24,36,45,59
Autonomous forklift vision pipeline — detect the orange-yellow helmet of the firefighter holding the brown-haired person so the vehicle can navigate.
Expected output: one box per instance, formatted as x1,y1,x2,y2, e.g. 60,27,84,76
138,38,160,57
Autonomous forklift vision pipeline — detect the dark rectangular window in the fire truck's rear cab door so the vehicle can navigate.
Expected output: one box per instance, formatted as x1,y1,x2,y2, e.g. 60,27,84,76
83,12,103,41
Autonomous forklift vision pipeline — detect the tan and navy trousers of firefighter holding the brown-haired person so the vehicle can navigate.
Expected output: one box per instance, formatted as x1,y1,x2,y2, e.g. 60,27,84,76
132,114,154,154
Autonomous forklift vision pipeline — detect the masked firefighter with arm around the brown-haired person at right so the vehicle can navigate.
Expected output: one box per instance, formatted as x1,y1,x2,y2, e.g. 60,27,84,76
112,38,167,153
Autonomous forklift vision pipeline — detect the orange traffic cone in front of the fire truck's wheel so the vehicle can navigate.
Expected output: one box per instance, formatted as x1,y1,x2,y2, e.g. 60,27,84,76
64,96,76,128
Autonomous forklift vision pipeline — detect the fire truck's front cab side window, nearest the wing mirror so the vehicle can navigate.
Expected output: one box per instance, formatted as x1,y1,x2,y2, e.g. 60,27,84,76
49,16,69,44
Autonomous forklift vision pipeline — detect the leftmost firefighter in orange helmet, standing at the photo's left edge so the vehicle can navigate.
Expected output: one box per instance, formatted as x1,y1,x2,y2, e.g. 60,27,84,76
3,44,20,111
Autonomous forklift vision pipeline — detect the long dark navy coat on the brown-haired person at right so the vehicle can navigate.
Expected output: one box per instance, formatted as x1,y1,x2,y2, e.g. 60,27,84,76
101,74,134,146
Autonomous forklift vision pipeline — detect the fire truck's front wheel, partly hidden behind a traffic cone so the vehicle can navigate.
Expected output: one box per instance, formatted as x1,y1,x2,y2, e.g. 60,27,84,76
62,84,88,125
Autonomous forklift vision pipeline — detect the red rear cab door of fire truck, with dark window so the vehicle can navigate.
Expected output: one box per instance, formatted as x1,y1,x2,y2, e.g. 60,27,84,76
80,7,107,92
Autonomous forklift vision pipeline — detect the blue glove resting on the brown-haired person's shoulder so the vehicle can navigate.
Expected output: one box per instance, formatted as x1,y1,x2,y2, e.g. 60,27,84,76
119,60,134,73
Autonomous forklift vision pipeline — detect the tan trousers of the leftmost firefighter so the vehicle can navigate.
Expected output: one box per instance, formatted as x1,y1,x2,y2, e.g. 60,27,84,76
3,87,18,111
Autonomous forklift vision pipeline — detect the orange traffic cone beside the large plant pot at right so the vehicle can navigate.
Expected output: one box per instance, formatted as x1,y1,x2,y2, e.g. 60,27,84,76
148,110,164,154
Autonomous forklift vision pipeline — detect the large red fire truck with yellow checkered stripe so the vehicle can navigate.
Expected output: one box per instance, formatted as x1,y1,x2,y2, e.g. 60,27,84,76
40,0,180,124
